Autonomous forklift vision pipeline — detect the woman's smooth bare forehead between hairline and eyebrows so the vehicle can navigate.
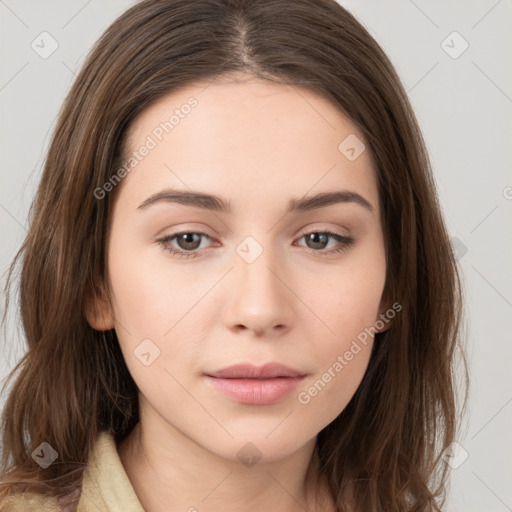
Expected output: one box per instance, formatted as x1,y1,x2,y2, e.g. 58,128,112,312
118,74,378,212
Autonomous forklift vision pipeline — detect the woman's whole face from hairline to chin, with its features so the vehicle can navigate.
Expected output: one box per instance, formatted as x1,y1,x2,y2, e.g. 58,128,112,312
90,73,386,460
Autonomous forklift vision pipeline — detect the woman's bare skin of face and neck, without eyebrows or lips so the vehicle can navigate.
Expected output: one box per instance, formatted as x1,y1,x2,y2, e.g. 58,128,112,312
89,76,389,512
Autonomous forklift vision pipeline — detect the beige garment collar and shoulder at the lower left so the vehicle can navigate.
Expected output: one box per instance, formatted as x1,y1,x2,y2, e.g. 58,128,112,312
0,432,145,512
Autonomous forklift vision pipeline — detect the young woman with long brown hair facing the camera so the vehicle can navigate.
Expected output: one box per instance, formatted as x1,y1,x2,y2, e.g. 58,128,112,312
0,0,465,511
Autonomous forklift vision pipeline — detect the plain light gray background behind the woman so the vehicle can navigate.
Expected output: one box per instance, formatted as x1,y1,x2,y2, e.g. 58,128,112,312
0,0,512,512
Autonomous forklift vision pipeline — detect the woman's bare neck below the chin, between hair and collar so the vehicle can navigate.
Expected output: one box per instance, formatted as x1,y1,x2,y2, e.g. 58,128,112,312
118,421,332,512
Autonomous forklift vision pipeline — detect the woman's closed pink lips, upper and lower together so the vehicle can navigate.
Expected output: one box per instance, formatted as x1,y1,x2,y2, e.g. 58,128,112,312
205,363,305,405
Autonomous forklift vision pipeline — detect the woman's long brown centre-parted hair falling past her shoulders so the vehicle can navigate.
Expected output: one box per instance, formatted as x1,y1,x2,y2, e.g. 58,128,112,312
0,0,468,512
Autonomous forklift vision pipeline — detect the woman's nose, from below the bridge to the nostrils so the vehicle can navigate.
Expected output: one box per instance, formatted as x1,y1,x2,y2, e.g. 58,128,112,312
223,242,294,339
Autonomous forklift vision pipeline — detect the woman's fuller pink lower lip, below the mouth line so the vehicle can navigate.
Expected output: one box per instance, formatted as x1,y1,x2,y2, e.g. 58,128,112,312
206,375,304,405
